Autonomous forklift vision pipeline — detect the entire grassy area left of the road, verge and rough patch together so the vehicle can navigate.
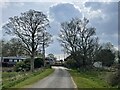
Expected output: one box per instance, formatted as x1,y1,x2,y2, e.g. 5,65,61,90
2,69,54,89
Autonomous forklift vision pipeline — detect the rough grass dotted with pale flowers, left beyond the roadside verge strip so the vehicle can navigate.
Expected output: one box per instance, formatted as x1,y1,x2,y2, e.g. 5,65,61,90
2,72,32,88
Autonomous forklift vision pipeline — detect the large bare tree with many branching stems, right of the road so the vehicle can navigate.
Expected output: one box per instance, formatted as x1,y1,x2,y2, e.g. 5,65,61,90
59,18,100,66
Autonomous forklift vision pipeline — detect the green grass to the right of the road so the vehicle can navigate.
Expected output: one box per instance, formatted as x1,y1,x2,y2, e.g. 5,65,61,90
69,70,111,88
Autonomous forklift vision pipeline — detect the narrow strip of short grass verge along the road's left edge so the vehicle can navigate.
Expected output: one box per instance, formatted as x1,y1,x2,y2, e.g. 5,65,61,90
3,69,54,89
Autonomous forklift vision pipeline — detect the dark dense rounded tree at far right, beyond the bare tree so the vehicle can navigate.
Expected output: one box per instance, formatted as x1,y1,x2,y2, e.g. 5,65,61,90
96,42,115,66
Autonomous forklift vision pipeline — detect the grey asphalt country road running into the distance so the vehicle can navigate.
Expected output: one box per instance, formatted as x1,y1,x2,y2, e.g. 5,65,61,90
29,67,76,88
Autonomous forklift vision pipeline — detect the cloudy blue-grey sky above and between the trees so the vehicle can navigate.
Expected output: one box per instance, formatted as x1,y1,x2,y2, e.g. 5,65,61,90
0,0,118,58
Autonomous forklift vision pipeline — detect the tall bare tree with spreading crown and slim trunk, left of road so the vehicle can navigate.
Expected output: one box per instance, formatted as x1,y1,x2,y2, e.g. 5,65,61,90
3,10,49,71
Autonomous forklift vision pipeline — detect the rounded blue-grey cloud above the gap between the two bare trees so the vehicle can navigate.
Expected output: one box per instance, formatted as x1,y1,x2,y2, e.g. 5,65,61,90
49,3,82,22
